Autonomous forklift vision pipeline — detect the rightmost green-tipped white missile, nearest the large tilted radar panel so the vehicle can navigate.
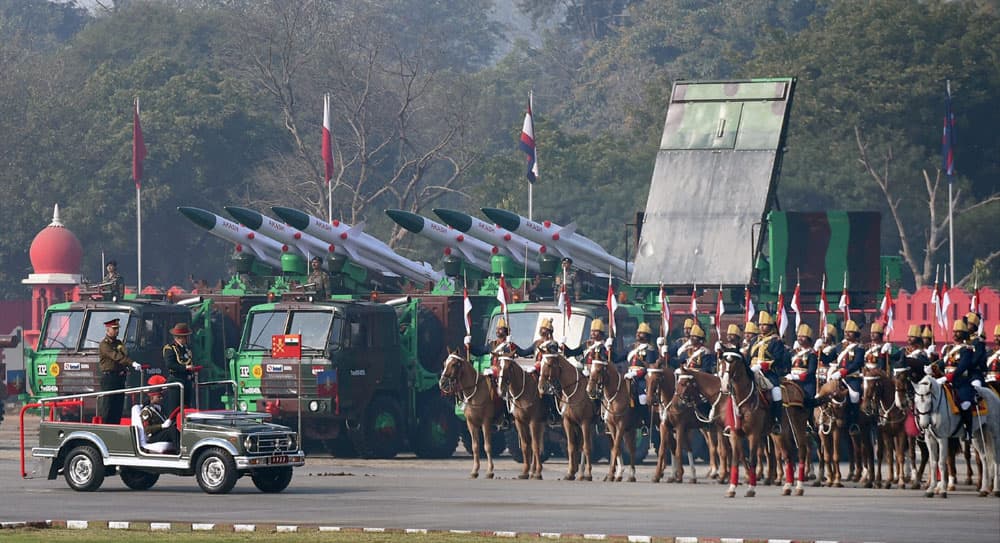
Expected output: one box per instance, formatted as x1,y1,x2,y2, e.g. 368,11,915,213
483,208,632,280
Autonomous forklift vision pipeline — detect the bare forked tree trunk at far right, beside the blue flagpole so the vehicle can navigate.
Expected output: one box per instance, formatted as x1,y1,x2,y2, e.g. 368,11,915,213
854,126,1000,288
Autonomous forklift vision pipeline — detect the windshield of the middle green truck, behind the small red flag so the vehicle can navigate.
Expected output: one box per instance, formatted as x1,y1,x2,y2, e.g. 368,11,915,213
242,311,340,351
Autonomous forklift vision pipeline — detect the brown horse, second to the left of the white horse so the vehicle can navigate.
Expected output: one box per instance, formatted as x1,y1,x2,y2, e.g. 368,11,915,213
861,369,906,488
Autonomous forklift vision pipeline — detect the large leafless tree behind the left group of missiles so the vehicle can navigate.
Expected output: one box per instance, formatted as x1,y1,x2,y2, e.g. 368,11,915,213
226,1,477,249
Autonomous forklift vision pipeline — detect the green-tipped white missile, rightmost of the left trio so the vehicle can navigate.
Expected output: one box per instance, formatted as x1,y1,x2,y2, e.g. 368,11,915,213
271,206,444,283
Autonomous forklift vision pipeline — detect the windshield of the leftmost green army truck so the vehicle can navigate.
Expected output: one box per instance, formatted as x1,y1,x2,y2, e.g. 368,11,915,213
40,310,135,350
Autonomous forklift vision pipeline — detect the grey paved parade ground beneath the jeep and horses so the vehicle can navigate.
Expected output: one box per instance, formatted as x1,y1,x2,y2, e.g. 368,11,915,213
0,416,1000,543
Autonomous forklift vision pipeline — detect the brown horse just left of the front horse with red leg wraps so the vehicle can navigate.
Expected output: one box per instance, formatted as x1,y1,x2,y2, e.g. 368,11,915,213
674,368,730,483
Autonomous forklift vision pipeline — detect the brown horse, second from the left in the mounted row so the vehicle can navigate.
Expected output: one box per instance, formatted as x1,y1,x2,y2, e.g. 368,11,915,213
500,356,545,479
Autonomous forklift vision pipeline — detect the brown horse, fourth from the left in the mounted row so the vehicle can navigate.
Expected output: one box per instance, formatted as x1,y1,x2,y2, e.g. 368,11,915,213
587,360,640,483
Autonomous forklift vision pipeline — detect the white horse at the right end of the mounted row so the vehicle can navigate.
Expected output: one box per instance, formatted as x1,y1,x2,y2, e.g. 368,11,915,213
913,376,1000,498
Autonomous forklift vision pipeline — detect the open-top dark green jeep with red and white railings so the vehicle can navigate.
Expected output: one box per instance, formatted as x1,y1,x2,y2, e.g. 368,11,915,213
21,382,305,494
